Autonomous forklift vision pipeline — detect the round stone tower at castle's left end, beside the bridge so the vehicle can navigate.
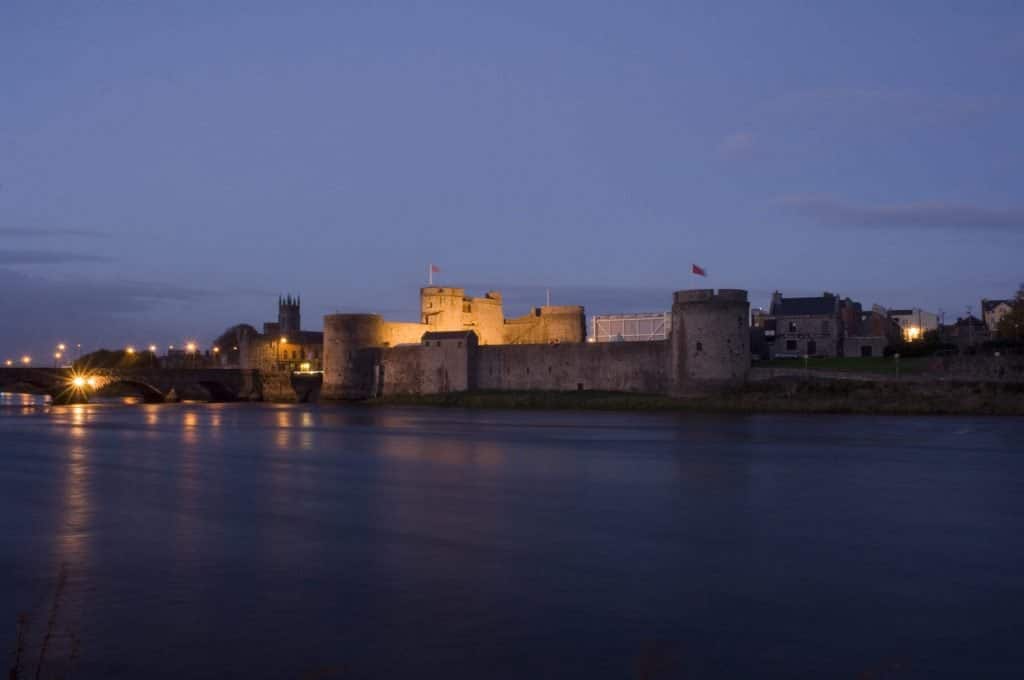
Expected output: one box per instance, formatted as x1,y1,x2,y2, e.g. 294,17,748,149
321,314,384,399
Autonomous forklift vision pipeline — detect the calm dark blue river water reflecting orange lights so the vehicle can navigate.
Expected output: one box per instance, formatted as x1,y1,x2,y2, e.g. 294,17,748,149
0,396,1024,678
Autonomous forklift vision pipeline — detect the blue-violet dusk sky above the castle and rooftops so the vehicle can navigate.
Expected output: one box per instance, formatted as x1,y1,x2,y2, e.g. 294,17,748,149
0,0,1024,358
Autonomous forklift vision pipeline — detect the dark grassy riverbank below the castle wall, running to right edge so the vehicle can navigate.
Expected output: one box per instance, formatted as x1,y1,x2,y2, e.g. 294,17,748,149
367,380,1024,416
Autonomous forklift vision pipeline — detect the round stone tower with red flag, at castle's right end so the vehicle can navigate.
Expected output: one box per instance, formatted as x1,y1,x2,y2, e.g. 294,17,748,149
671,289,751,394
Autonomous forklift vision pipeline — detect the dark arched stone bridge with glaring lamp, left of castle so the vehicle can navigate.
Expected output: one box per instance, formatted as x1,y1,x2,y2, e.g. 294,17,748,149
0,368,307,403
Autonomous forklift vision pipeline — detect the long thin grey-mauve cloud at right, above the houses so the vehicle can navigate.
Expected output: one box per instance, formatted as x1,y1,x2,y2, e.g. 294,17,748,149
775,196,1024,231
